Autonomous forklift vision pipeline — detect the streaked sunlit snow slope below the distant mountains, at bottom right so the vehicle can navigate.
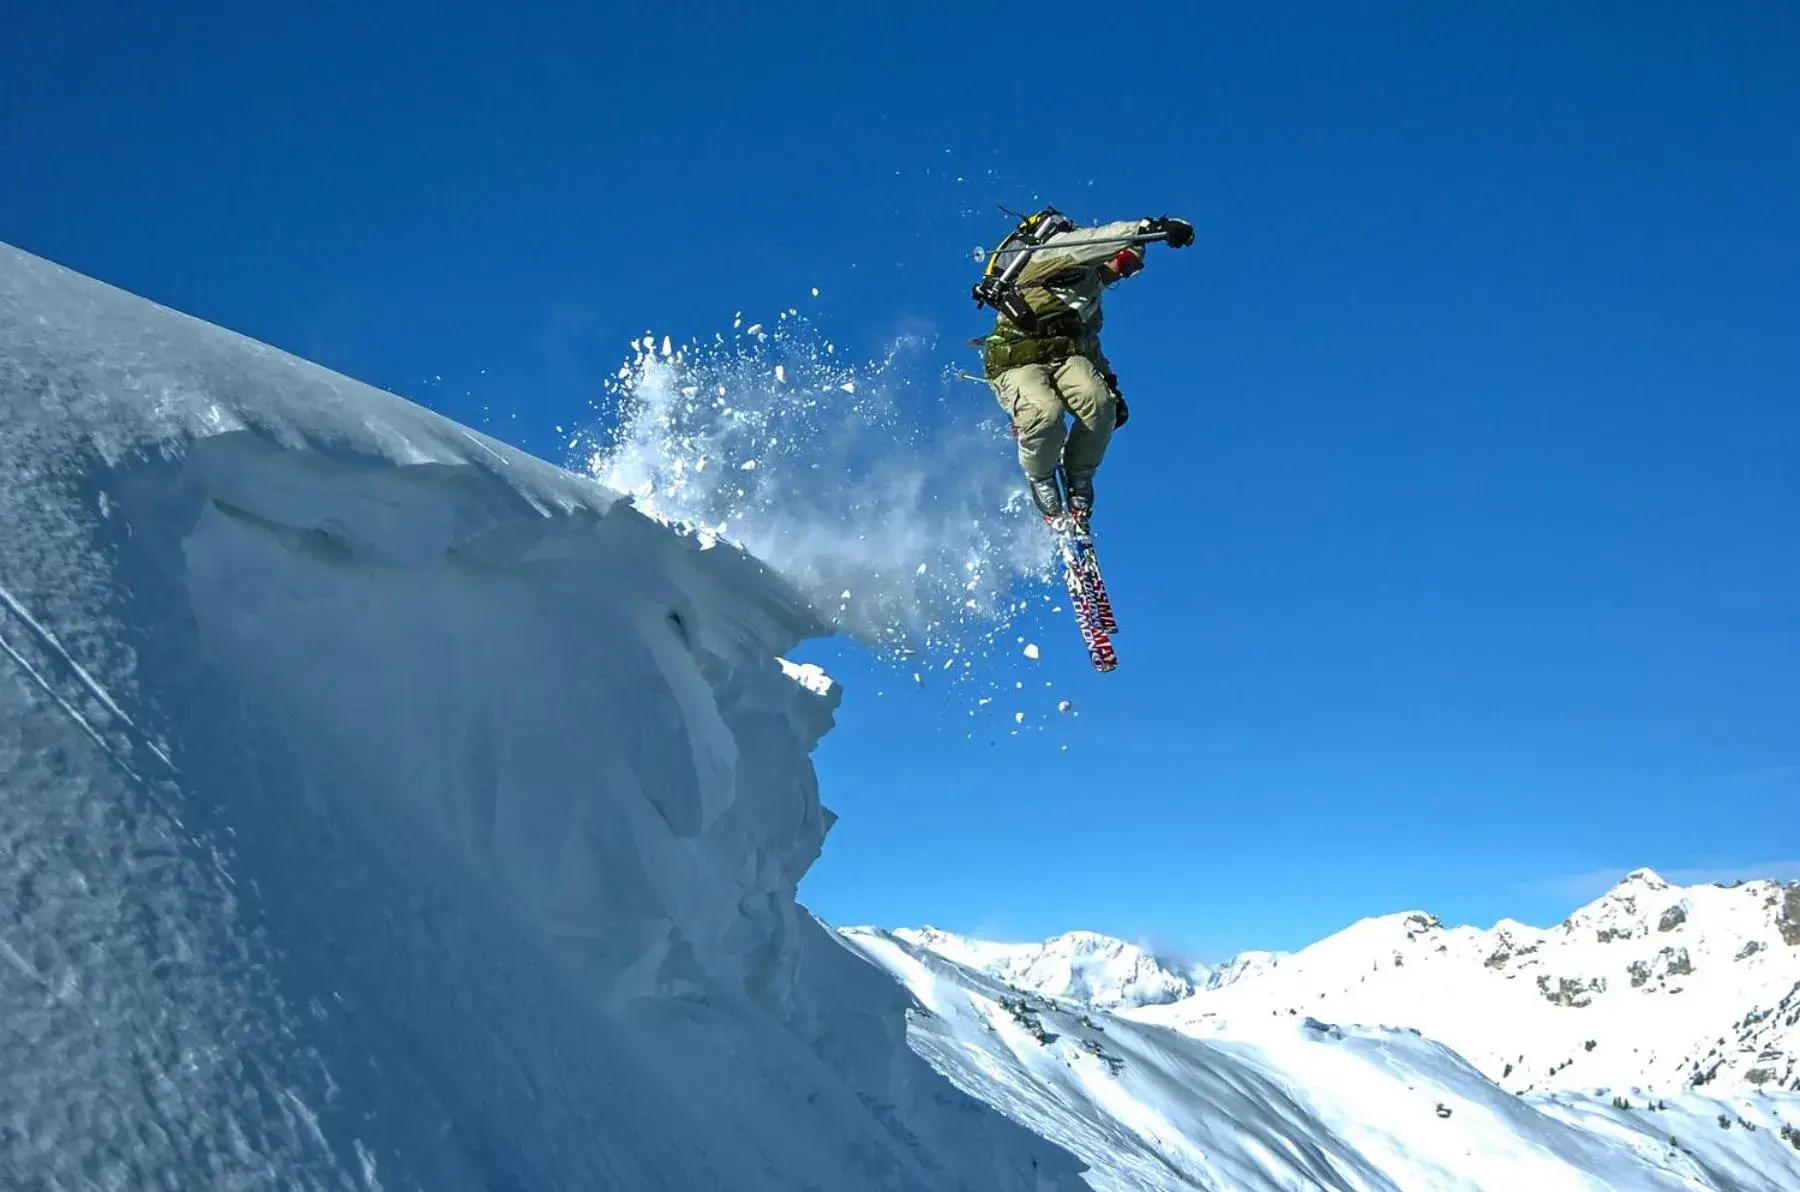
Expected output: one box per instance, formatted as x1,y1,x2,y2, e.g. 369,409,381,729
842,927,1800,1192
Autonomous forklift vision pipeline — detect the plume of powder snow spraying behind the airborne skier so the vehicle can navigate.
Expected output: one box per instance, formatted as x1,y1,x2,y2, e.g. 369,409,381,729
571,312,1049,659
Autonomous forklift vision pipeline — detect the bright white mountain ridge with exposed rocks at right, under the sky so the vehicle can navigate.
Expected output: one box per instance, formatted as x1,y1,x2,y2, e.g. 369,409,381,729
1143,870,1800,1093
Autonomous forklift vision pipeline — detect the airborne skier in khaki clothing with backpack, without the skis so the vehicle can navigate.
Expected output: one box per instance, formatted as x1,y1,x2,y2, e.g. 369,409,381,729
976,207,1193,526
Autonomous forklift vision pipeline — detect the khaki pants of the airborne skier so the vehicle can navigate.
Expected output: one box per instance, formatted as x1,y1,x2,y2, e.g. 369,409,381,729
992,357,1118,481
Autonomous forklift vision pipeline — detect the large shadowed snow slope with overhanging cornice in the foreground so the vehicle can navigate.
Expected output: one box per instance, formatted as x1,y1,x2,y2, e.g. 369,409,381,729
0,247,1078,1192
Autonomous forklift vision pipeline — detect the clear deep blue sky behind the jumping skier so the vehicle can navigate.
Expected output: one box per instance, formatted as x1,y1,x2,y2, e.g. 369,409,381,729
0,0,1800,958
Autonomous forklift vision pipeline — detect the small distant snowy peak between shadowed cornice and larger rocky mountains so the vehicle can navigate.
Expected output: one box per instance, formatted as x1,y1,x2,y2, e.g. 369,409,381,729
895,927,1211,1010
